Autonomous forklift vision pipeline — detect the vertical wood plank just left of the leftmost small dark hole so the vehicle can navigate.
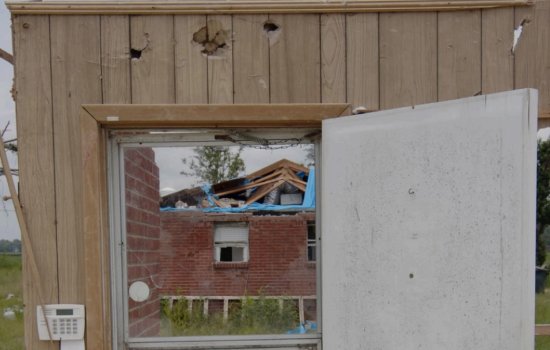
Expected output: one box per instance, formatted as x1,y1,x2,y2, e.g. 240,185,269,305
101,16,131,103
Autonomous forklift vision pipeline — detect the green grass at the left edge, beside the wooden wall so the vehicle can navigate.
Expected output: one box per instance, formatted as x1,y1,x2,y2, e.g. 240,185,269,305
0,254,24,350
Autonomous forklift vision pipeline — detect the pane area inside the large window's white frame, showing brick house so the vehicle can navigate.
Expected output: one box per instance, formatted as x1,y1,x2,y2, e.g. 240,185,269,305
122,136,317,338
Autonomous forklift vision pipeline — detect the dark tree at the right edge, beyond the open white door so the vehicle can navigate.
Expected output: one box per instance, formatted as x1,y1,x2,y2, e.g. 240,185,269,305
536,140,550,266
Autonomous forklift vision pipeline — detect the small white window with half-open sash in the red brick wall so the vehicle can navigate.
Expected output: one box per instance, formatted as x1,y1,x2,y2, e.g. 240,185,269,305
214,222,248,262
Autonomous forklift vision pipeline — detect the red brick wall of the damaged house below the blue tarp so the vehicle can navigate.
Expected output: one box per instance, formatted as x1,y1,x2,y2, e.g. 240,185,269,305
160,212,316,296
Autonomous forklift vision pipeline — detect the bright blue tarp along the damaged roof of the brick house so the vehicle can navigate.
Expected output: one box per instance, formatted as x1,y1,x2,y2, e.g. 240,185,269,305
160,167,315,213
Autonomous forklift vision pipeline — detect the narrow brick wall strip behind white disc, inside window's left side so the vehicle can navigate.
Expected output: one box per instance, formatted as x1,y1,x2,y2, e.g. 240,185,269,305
124,148,164,337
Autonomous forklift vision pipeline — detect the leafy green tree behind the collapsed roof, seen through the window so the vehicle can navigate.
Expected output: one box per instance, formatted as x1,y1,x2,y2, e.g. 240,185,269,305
181,146,245,184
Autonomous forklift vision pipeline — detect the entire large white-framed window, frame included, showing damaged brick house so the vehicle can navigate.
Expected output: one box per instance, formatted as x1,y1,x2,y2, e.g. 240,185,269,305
110,129,321,349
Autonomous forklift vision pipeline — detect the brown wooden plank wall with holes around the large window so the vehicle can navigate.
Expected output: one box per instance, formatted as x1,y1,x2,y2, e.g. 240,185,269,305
13,0,550,349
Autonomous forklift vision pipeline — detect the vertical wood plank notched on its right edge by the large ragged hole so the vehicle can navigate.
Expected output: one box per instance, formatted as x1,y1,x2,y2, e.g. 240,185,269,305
174,16,208,103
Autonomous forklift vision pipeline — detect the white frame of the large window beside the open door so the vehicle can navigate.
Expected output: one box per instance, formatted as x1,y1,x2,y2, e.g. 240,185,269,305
107,128,322,350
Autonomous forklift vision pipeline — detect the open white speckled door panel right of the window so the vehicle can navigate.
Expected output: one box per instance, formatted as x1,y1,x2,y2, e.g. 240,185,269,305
322,90,537,350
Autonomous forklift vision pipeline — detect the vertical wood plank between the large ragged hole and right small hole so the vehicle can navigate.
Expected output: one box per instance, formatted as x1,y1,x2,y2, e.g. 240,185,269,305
233,15,269,103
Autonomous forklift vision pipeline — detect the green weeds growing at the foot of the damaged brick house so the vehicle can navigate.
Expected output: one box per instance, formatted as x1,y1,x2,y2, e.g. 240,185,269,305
162,296,298,336
